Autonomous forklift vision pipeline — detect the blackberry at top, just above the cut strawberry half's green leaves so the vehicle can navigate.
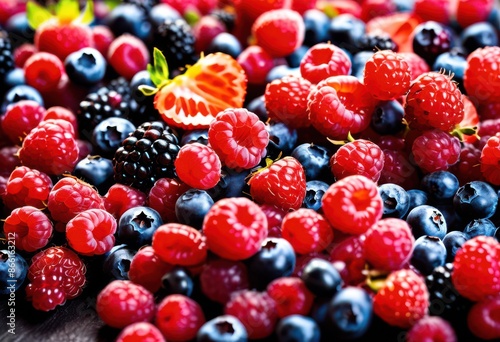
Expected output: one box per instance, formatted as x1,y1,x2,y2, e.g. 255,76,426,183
153,19,197,72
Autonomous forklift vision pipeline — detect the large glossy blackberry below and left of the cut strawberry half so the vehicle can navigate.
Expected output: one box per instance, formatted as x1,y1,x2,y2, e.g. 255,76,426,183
113,121,180,193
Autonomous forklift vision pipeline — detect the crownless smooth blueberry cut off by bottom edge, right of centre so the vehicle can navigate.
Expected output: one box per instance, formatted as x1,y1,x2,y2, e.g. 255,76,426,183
276,314,320,342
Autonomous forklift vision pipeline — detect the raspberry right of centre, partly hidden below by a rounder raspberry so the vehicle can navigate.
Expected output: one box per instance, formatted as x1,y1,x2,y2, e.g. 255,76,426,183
330,139,385,182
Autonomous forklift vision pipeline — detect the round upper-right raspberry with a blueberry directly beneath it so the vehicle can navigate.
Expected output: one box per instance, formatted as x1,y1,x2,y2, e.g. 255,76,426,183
363,50,411,101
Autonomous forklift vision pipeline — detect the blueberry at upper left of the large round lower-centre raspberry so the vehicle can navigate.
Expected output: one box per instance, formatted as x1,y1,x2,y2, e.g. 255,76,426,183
175,189,214,229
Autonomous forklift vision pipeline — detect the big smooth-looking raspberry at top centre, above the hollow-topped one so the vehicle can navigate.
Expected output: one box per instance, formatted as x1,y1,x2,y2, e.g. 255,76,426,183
252,9,306,58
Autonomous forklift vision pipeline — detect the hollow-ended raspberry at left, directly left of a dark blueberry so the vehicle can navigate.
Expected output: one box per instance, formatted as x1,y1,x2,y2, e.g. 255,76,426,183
66,209,117,256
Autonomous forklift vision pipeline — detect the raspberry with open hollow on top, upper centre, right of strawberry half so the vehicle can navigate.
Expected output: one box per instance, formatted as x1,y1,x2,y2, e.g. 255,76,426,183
300,43,352,84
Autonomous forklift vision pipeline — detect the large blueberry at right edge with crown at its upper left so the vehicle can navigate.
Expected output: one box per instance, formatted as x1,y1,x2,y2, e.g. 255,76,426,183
453,181,498,221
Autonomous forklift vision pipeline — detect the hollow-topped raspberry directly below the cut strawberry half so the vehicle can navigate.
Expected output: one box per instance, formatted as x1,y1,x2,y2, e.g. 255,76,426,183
208,108,269,169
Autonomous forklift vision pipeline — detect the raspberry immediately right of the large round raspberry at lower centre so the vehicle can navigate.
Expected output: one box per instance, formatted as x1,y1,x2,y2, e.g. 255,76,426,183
281,208,333,254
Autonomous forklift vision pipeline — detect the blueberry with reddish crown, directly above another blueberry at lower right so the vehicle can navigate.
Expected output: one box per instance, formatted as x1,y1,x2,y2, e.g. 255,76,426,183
406,204,448,239
